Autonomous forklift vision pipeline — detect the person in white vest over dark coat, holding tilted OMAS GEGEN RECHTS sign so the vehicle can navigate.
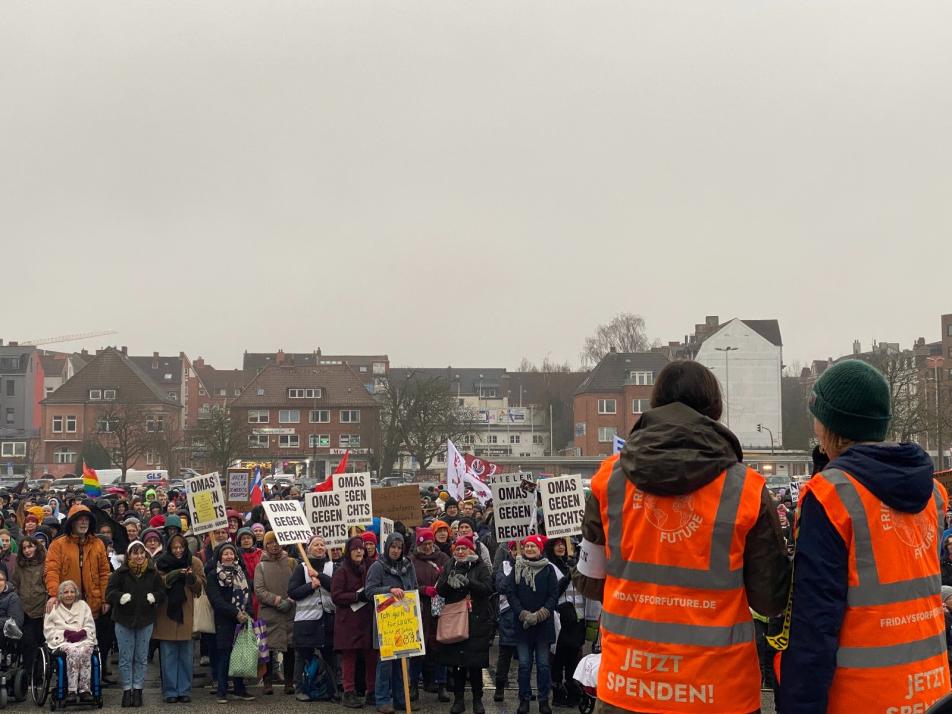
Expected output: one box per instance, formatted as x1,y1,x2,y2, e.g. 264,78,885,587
288,536,333,702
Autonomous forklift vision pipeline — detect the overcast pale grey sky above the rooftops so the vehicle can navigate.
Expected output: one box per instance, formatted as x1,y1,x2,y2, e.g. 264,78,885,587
0,5,952,368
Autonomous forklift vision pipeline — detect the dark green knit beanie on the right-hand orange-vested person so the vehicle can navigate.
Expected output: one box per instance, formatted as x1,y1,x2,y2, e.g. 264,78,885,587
810,359,892,441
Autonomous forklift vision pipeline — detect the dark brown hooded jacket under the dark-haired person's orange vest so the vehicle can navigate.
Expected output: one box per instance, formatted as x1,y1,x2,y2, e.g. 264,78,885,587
573,402,790,616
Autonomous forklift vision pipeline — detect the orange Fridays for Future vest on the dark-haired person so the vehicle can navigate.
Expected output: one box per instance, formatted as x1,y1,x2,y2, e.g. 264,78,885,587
591,456,764,714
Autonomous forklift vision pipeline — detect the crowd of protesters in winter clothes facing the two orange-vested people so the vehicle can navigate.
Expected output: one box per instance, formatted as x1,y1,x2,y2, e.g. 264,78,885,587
0,476,600,714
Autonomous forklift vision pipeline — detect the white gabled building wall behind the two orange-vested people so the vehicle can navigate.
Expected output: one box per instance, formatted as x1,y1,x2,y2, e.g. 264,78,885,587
696,318,783,449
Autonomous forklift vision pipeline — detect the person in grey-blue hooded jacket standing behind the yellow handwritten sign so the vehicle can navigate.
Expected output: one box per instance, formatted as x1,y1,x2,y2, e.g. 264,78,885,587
365,533,417,714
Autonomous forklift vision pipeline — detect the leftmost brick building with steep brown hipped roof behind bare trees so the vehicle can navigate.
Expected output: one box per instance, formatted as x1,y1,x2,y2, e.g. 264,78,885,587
38,347,183,476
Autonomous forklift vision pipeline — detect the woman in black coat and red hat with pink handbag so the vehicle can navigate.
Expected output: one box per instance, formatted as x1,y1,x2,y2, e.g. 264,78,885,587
436,538,493,714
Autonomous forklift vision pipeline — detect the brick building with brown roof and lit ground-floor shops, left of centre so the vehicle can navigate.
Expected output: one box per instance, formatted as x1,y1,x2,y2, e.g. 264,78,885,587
231,364,380,477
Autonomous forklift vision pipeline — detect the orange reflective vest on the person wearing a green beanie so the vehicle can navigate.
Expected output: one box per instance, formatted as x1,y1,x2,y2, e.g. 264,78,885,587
794,469,949,714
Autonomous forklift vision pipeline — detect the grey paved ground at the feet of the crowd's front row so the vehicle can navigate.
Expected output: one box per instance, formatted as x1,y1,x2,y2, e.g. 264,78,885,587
7,656,774,714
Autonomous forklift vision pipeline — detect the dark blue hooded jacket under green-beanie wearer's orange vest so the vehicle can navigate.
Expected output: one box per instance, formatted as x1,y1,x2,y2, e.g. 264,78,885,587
777,444,933,714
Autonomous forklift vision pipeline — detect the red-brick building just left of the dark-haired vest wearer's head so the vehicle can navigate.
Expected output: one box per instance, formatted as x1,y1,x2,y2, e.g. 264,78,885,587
574,351,668,456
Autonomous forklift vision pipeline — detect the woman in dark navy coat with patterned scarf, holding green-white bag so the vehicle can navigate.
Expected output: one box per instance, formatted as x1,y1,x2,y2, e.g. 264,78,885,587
205,542,254,704
